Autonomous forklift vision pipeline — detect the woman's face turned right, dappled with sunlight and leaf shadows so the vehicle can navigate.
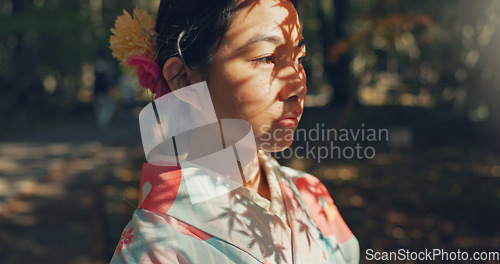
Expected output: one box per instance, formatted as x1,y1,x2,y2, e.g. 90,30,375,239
208,0,307,151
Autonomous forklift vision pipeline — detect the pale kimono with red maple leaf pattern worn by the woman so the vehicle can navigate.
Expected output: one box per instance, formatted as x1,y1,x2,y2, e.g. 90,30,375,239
111,152,359,264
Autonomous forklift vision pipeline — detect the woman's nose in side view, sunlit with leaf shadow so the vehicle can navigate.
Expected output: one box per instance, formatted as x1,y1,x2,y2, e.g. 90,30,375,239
278,65,307,101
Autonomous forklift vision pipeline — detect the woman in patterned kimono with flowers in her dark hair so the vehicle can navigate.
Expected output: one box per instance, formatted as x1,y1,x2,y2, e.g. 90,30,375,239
111,0,359,263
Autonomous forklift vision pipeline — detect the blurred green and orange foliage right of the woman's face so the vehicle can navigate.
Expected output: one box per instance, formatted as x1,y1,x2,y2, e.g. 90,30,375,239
302,0,500,128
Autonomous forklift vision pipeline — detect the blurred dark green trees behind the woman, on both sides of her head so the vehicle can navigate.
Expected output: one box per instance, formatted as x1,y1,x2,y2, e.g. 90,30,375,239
0,0,500,120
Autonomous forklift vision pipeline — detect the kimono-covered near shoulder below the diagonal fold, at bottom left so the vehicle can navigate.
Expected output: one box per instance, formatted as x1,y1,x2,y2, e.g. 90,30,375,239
110,209,258,264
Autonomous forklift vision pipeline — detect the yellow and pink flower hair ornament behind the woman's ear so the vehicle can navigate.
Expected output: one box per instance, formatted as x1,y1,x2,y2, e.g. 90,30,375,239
109,8,170,98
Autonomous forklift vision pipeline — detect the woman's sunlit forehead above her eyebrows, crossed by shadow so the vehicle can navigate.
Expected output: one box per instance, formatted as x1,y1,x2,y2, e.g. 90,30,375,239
223,0,302,46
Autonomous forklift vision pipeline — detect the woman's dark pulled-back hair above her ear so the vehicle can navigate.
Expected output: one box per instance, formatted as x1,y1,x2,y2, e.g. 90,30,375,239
155,0,236,77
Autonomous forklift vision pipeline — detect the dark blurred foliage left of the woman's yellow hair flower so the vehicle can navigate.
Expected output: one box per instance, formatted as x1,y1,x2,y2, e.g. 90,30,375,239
0,0,137,103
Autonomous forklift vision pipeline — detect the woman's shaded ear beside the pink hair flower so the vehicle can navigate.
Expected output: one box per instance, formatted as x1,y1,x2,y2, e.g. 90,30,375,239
162,56,203,91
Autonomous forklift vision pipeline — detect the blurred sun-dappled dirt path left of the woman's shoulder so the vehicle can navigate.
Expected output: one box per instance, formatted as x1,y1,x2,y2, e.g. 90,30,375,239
0,119,140,264
